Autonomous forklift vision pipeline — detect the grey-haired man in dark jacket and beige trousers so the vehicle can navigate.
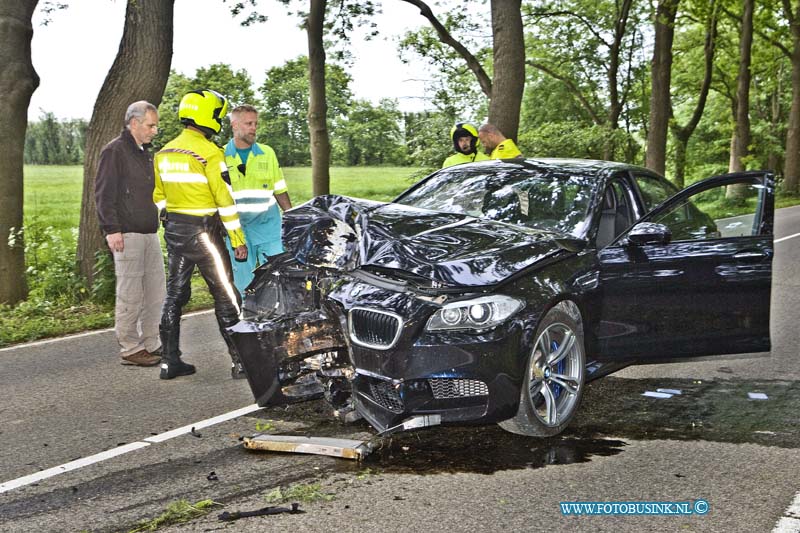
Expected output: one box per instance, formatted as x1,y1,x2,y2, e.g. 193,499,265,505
95,101,166,366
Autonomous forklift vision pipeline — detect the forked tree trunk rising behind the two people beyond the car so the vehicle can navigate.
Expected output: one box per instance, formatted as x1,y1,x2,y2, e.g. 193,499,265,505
403,0,525,139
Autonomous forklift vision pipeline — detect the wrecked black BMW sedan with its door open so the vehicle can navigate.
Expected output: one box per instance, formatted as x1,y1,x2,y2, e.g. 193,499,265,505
227,159,774,436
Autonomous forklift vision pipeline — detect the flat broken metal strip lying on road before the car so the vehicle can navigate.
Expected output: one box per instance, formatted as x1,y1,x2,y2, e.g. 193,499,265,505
244,434,372,461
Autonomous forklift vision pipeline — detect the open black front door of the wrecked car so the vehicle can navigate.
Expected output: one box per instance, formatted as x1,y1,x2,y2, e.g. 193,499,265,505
594,172,774,360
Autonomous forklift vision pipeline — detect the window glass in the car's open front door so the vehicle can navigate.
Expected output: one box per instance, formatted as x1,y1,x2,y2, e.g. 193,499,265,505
652,183,763,241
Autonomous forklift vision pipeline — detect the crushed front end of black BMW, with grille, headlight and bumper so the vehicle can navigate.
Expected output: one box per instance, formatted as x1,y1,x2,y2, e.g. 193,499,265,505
232,197,560,432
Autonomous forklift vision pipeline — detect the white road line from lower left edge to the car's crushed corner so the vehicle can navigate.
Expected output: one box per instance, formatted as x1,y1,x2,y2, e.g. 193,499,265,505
0,404,261,494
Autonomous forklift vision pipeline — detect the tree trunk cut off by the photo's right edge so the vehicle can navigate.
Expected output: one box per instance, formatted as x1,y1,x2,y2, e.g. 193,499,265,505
783,1,800,194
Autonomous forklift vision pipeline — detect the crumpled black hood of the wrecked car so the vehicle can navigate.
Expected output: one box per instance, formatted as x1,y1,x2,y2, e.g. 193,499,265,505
283,195,575,288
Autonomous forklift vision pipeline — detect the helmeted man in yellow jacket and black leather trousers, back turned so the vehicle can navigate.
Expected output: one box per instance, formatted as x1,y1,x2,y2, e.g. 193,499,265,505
153,89,247,379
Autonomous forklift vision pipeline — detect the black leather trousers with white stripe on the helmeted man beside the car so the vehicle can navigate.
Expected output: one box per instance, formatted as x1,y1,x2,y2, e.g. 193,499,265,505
159,215,242,362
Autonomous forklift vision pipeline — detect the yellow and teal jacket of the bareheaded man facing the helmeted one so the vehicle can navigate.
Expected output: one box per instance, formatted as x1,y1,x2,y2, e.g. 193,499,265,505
225,139,288,244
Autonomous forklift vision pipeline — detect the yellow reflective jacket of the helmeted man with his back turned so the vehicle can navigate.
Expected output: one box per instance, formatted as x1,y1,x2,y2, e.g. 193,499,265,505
153,128,245,248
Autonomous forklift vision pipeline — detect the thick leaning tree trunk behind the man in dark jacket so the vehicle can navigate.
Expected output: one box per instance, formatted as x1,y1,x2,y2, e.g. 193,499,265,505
78,0,174,283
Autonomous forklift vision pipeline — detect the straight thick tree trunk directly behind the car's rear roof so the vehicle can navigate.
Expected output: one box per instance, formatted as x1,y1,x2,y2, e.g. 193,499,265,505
645,0,685,176
